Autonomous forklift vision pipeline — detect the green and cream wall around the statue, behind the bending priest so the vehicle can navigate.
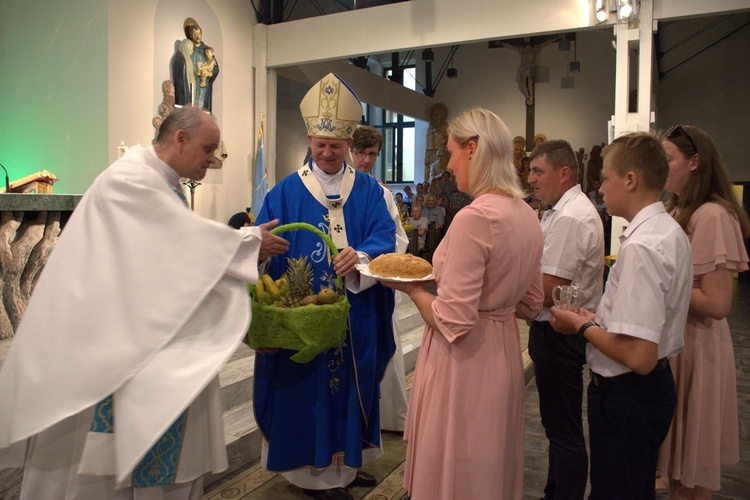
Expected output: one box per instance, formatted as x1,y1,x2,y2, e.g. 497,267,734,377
0,0,255,220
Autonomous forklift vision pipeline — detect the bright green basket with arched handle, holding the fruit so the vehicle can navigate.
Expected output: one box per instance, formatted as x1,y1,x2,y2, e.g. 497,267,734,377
248,222,349,363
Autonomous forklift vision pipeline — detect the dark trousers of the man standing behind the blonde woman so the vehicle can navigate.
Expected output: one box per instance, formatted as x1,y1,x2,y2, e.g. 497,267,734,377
529,321,588,499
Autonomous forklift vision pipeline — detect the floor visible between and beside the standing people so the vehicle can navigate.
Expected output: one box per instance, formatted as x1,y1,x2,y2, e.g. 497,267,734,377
204,281,750,500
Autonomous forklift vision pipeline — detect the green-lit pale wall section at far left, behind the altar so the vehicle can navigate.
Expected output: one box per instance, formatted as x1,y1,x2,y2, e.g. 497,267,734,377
0,0,108,198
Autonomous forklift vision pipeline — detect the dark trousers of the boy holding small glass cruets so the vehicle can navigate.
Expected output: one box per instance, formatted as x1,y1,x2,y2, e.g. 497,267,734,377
588,366,677,500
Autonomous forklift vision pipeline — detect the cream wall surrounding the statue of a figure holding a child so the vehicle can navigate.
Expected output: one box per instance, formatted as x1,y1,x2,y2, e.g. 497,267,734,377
114,0,255,221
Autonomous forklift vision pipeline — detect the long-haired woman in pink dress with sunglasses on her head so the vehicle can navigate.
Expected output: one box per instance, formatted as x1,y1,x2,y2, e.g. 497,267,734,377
658,125,750,499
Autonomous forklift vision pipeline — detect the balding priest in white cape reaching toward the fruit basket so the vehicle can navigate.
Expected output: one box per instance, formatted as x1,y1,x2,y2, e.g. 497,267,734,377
0,107,289,500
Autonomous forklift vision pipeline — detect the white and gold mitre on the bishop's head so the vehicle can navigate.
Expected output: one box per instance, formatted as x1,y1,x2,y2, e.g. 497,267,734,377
299,73,362,139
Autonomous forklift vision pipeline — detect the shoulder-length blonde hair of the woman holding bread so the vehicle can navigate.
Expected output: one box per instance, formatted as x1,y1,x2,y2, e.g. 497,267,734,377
448,108,525,199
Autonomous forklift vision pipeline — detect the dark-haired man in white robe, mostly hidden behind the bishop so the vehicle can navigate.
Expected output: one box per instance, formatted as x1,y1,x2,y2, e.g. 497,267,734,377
349,125,409,432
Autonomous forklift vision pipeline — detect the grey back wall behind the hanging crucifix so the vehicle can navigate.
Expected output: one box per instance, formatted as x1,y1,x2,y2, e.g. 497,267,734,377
426,29,615,158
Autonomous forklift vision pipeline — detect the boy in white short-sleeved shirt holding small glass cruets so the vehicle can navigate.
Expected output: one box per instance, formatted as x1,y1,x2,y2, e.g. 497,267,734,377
550,132,693,499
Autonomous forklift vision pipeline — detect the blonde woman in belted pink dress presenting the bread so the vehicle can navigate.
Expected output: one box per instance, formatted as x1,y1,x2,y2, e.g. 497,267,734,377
385,109,544,500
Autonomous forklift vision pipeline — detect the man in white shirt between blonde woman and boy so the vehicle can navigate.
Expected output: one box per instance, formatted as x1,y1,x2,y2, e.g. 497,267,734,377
529,140,604,499
